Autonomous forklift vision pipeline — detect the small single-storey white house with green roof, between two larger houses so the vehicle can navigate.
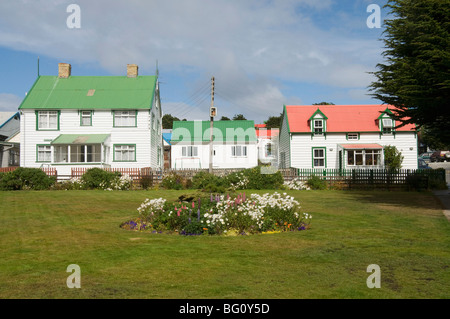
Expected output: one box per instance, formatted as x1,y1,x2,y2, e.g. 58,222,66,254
171,121,258,169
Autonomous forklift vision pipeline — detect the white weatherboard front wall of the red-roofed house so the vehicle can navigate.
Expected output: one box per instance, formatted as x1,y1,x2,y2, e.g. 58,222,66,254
288,130,418,169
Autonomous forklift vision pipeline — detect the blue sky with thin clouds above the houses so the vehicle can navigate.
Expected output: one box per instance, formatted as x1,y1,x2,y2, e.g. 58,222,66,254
0,0,387,123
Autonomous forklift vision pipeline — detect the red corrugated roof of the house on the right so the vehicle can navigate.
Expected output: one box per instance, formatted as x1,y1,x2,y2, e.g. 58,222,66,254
286,104,415,133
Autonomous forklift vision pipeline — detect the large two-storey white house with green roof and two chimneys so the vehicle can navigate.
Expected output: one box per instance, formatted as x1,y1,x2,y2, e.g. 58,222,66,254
19,63,163,175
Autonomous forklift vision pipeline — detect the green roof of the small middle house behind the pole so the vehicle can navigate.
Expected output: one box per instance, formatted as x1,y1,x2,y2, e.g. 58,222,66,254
171,121,257,143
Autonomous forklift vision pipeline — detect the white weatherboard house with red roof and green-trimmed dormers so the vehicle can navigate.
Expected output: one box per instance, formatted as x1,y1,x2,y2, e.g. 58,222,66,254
279,105,418,169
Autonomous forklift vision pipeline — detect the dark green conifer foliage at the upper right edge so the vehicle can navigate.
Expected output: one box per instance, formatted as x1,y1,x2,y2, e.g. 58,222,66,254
369,0,450,144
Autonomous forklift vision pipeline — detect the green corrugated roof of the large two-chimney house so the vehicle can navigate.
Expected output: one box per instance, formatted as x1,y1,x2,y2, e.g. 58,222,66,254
19,76,157,109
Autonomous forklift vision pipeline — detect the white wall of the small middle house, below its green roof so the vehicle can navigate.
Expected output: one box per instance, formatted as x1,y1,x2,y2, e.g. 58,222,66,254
171,142,258,169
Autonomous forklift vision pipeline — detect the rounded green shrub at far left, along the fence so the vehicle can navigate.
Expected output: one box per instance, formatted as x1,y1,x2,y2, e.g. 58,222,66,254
0,167,56,190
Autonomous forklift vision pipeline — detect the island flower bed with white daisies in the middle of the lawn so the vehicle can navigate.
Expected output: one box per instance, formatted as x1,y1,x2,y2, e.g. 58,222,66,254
121,192,312,235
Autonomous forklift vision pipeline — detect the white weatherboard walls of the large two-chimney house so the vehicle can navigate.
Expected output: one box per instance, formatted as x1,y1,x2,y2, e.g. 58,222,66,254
20,108,163,175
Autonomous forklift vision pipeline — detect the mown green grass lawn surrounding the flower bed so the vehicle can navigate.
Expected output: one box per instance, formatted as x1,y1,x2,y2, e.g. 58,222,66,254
0,191,450,299
